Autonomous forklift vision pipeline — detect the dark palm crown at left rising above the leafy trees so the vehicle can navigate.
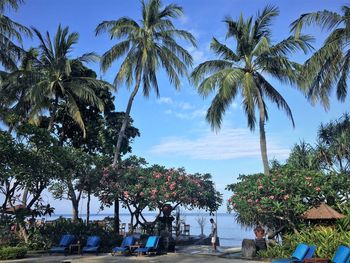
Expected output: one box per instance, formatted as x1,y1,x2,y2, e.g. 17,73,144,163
30,25,107,137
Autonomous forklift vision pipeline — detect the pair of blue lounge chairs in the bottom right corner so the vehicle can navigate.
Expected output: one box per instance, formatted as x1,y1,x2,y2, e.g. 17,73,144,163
272,244,350,263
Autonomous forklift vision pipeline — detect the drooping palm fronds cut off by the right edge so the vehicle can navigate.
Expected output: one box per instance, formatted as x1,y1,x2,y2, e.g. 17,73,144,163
292,5,350,109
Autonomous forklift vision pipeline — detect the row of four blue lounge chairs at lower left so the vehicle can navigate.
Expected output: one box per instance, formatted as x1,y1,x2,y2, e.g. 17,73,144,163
49,235,160,255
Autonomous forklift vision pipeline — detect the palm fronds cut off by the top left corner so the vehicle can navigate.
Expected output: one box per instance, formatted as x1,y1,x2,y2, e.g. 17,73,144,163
0,0,32,70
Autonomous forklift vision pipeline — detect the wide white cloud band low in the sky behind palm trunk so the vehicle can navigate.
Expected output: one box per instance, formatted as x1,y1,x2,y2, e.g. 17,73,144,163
150,128,289,160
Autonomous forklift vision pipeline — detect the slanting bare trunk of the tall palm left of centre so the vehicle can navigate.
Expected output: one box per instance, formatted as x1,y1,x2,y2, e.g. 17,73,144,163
112,73,141,167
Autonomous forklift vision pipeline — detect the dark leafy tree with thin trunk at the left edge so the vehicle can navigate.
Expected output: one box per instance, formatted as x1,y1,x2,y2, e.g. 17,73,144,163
0,125,62,242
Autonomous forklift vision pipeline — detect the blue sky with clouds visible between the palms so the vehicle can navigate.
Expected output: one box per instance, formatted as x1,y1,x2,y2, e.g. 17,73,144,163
5,0,349,213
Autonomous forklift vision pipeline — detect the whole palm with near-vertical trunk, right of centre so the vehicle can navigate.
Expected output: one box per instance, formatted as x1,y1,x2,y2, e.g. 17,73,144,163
192,6,311,175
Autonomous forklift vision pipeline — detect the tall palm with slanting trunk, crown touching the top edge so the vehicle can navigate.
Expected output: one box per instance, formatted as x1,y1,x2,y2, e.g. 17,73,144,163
96,0,195,166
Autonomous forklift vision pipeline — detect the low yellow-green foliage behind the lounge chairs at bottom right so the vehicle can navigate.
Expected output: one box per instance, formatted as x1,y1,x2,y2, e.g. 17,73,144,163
259,227,350,259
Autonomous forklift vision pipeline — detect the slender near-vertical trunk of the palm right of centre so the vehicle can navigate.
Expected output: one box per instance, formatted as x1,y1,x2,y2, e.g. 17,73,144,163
257,91,270,176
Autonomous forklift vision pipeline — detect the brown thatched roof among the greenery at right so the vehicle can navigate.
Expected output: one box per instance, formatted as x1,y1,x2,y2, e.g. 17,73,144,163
303,203,346,224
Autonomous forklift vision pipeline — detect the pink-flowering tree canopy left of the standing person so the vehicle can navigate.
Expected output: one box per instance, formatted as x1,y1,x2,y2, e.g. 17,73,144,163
99,157,222,229
